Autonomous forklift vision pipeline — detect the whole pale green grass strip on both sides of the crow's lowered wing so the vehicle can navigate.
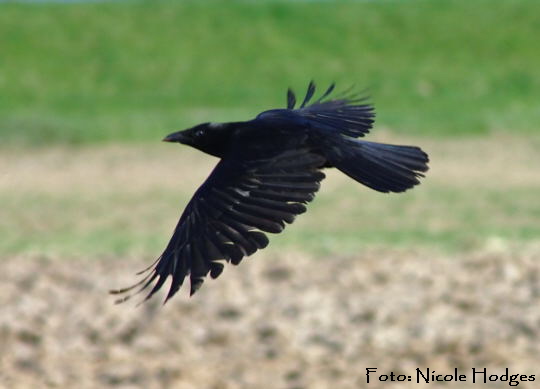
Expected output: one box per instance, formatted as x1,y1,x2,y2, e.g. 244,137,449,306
0,184,540,256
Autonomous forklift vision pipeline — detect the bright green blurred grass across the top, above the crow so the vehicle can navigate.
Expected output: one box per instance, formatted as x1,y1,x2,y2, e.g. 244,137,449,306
0,0,540,145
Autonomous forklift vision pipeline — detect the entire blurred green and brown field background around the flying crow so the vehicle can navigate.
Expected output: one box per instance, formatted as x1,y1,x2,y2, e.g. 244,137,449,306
0,0,540,389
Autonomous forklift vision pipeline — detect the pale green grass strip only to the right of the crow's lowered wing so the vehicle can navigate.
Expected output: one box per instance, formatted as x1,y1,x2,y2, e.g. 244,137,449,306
275,184,540,254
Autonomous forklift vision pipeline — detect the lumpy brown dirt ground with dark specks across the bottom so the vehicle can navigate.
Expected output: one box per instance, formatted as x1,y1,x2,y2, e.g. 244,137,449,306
0,242,540,389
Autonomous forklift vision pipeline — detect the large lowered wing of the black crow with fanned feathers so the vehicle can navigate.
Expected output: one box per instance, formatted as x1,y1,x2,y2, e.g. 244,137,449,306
111,149,324,302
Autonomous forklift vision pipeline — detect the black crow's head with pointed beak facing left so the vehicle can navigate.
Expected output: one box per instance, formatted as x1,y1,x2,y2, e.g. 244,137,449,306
163,123,229,156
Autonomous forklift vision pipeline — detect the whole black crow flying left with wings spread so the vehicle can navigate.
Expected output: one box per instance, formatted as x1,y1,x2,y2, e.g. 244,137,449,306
111,82,429,302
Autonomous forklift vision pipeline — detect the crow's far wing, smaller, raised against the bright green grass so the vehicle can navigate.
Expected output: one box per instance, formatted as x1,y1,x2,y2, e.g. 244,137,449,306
287,81,375,138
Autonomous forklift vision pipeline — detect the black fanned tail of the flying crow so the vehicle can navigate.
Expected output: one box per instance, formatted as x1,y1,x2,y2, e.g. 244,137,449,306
325,136,429,192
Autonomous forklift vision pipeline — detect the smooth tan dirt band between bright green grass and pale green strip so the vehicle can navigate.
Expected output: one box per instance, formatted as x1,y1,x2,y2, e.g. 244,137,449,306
0,131,540,193
